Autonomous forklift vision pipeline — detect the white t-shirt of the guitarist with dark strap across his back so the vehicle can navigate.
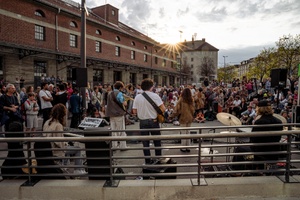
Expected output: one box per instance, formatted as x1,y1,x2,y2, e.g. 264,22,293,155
132,91,163,120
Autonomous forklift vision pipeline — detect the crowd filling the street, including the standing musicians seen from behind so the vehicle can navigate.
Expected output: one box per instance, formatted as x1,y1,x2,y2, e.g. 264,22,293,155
0,77,298,178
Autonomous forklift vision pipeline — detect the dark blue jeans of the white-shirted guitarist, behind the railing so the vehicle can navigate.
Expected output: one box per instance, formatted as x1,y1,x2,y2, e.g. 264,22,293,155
140,119,161,164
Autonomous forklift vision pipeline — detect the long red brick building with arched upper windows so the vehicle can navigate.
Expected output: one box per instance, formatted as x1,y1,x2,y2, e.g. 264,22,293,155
0,0,180,87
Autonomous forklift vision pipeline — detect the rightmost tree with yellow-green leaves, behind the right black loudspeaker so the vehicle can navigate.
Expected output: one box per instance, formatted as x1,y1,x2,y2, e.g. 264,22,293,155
276,34,300,75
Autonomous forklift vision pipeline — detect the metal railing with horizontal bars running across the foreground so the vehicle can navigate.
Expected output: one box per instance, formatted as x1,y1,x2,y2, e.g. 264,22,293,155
0,124,300,187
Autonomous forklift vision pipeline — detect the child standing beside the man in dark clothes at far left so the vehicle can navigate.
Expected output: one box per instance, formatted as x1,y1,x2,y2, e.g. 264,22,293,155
24,92,39,134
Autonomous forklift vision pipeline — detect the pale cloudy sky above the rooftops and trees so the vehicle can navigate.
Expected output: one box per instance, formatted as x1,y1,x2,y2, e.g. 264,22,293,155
74,0,300,66
